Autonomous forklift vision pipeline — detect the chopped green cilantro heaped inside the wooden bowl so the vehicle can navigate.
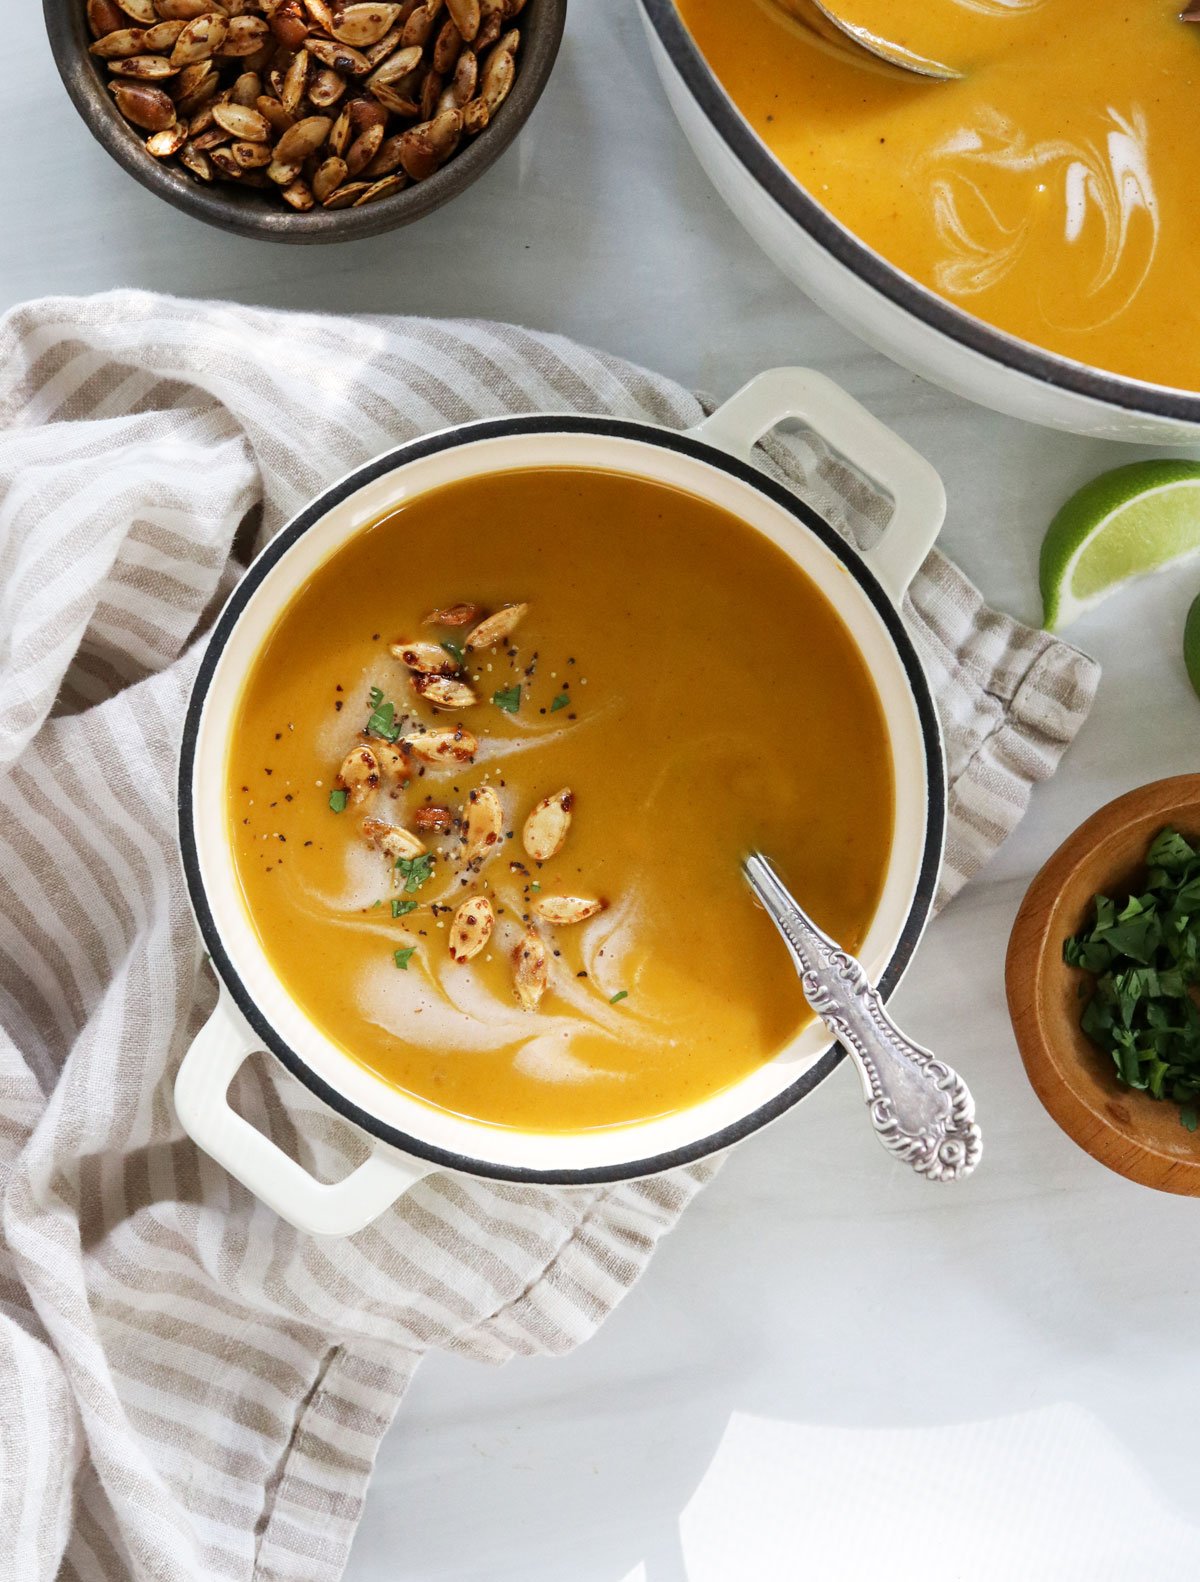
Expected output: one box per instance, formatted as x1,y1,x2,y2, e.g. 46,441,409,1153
1062,829,1200,1131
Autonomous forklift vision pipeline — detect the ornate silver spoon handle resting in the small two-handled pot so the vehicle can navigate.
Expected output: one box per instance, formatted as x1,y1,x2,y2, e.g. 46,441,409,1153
742,851,983,1182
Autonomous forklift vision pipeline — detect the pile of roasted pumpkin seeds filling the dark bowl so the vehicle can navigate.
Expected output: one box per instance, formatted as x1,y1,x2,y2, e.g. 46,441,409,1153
87,0,525,210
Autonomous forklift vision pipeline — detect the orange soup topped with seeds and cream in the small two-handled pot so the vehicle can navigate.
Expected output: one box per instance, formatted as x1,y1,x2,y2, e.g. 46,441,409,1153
226,468,893,1131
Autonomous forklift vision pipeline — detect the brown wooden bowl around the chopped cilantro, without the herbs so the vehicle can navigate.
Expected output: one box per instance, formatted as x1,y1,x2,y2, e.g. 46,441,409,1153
1006,775,1200,1198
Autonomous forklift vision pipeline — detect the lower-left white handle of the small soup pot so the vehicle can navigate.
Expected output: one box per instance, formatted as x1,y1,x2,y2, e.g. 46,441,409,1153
175,987,432,1236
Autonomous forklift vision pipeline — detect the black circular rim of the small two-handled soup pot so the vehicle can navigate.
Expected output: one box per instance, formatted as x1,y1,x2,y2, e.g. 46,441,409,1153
179,416,945,1187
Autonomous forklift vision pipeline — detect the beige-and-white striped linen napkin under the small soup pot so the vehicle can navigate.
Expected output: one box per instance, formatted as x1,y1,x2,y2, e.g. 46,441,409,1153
0,293,1097,1582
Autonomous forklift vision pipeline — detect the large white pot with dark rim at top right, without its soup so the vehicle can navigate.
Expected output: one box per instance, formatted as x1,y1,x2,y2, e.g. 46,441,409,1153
640,0,1200,445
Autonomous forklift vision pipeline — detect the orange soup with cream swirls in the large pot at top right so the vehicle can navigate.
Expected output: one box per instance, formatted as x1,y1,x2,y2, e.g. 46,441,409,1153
677,0,1200,391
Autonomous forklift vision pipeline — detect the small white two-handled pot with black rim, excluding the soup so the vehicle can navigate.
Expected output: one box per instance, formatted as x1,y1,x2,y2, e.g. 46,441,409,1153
175,369,945,1234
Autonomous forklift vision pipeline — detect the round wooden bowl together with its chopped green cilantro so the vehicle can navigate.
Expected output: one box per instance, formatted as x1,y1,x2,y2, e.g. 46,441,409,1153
1006,775,1200,1196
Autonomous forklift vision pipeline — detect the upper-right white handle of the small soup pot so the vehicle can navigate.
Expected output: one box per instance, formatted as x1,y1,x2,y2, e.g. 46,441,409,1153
688,369,945,604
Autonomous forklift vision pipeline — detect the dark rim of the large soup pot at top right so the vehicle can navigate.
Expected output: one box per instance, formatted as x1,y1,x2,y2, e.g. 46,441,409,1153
640,0,1200,426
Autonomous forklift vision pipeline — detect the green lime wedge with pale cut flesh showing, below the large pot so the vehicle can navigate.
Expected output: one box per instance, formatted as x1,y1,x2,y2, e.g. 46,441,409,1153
1040,460,1200,631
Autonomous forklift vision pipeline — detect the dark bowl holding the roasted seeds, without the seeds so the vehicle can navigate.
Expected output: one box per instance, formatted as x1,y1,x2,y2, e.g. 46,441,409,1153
43,0,566,242
